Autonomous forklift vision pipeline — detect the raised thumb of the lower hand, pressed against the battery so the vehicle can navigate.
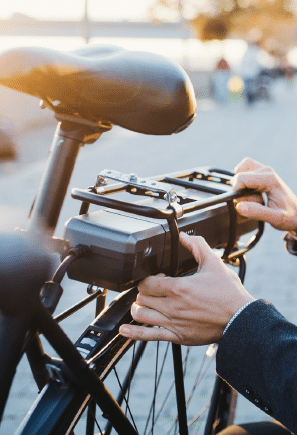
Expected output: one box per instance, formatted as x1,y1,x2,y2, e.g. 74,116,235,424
179,232,219,268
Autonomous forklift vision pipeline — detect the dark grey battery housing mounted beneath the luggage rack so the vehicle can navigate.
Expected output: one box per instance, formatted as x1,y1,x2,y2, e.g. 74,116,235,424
64,202,258,291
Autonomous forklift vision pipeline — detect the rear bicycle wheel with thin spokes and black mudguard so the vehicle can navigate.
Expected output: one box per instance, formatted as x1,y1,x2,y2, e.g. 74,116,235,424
17,289,224,435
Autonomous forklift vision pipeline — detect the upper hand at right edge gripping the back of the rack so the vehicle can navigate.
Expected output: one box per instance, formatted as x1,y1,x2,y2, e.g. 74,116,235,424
232,158,297,232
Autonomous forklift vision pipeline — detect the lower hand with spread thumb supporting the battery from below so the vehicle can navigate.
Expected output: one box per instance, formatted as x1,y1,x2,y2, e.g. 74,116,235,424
120,233,253,346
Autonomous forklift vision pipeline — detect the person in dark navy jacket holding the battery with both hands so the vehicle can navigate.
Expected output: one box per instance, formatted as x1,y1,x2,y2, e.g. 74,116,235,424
120,158,297,435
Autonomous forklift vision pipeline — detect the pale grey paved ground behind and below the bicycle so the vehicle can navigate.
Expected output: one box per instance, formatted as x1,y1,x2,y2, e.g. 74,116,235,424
0,82,297,435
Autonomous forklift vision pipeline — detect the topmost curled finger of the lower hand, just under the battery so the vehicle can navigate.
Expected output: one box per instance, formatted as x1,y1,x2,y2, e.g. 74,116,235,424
137,273,175,297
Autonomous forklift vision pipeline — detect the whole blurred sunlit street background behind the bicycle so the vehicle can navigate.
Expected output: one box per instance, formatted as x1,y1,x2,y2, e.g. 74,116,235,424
0,0,297,435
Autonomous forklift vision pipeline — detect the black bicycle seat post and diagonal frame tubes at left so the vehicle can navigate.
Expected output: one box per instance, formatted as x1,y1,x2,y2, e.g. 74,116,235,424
0,116,140,434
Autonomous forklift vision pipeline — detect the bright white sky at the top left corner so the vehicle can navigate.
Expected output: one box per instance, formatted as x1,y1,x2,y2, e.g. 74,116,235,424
0,0,153,21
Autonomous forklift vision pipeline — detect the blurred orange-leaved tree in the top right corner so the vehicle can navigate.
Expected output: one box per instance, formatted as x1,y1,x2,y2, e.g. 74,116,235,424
151,0,297,57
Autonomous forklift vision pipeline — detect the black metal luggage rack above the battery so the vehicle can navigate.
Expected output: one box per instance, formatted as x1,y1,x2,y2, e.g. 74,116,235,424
71,167,264,276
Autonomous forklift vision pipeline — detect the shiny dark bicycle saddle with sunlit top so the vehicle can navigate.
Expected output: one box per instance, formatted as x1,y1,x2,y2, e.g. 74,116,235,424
0,45,196,135
